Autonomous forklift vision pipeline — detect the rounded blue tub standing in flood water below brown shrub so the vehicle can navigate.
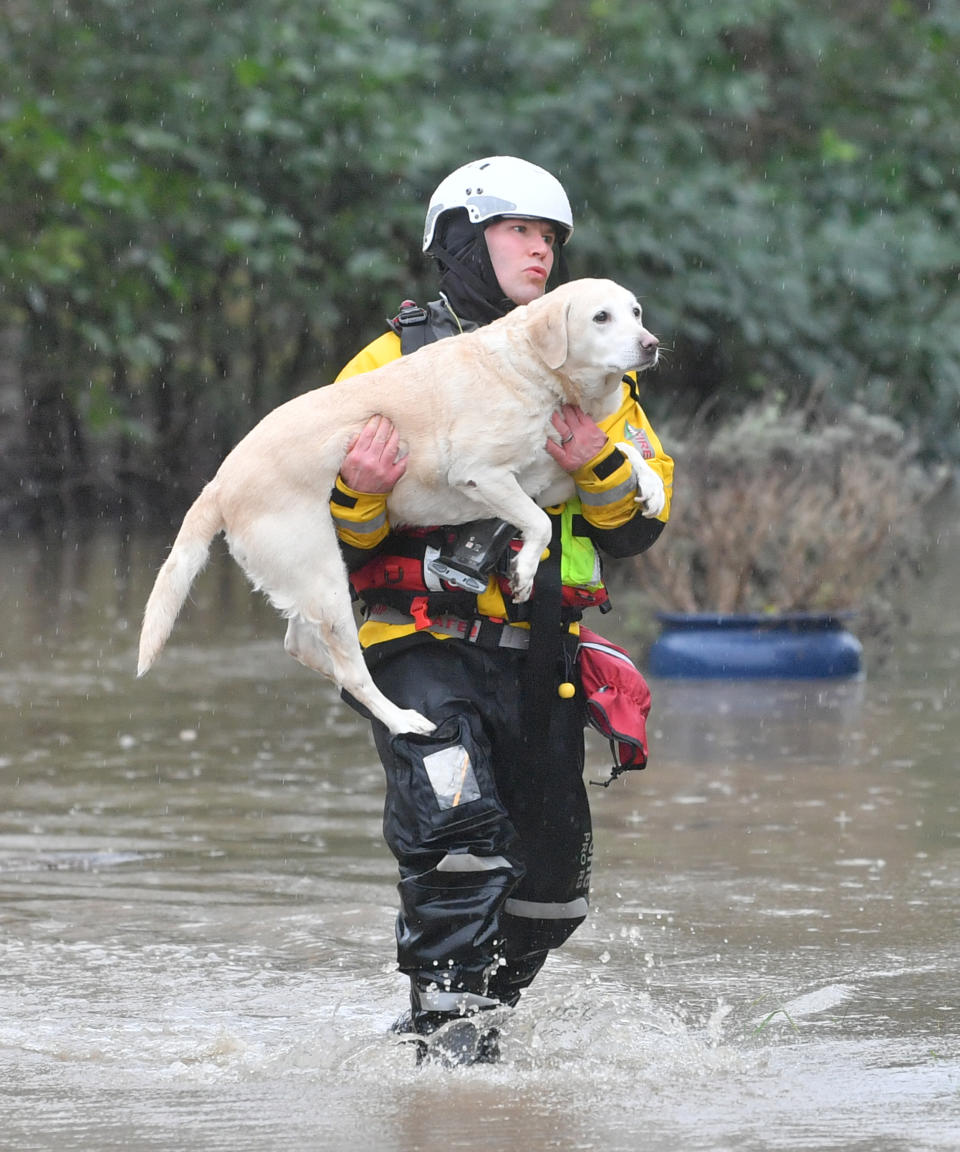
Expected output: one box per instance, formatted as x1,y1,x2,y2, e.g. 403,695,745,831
648,612,863,680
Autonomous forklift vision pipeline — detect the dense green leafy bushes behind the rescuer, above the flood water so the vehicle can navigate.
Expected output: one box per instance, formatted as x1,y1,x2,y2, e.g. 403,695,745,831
0,0,960,523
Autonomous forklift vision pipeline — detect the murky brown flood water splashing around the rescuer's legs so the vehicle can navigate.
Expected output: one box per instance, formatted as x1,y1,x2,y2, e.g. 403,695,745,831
0,523,960,1152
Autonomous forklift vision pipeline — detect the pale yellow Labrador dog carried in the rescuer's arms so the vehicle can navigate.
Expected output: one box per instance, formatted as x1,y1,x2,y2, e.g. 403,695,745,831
137,280,664,733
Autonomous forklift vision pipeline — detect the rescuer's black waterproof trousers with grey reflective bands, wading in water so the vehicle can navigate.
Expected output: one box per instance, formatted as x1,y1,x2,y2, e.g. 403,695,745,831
373,639,592,1029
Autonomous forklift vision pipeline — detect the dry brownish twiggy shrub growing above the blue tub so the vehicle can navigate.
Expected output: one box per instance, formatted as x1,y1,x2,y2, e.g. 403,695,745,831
635,392,948,622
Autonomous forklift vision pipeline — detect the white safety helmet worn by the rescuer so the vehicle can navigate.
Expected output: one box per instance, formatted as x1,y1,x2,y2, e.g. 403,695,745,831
423,156,573,252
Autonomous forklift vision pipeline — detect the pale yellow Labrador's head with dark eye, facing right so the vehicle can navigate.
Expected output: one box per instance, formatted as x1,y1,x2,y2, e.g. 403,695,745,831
527,280,659,384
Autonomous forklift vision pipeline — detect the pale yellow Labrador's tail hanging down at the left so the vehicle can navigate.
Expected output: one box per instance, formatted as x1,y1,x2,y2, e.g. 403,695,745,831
137,484,225,676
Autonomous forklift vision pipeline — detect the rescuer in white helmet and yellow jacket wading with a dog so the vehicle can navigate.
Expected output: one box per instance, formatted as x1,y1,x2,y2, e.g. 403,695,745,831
331,157,673,1063
